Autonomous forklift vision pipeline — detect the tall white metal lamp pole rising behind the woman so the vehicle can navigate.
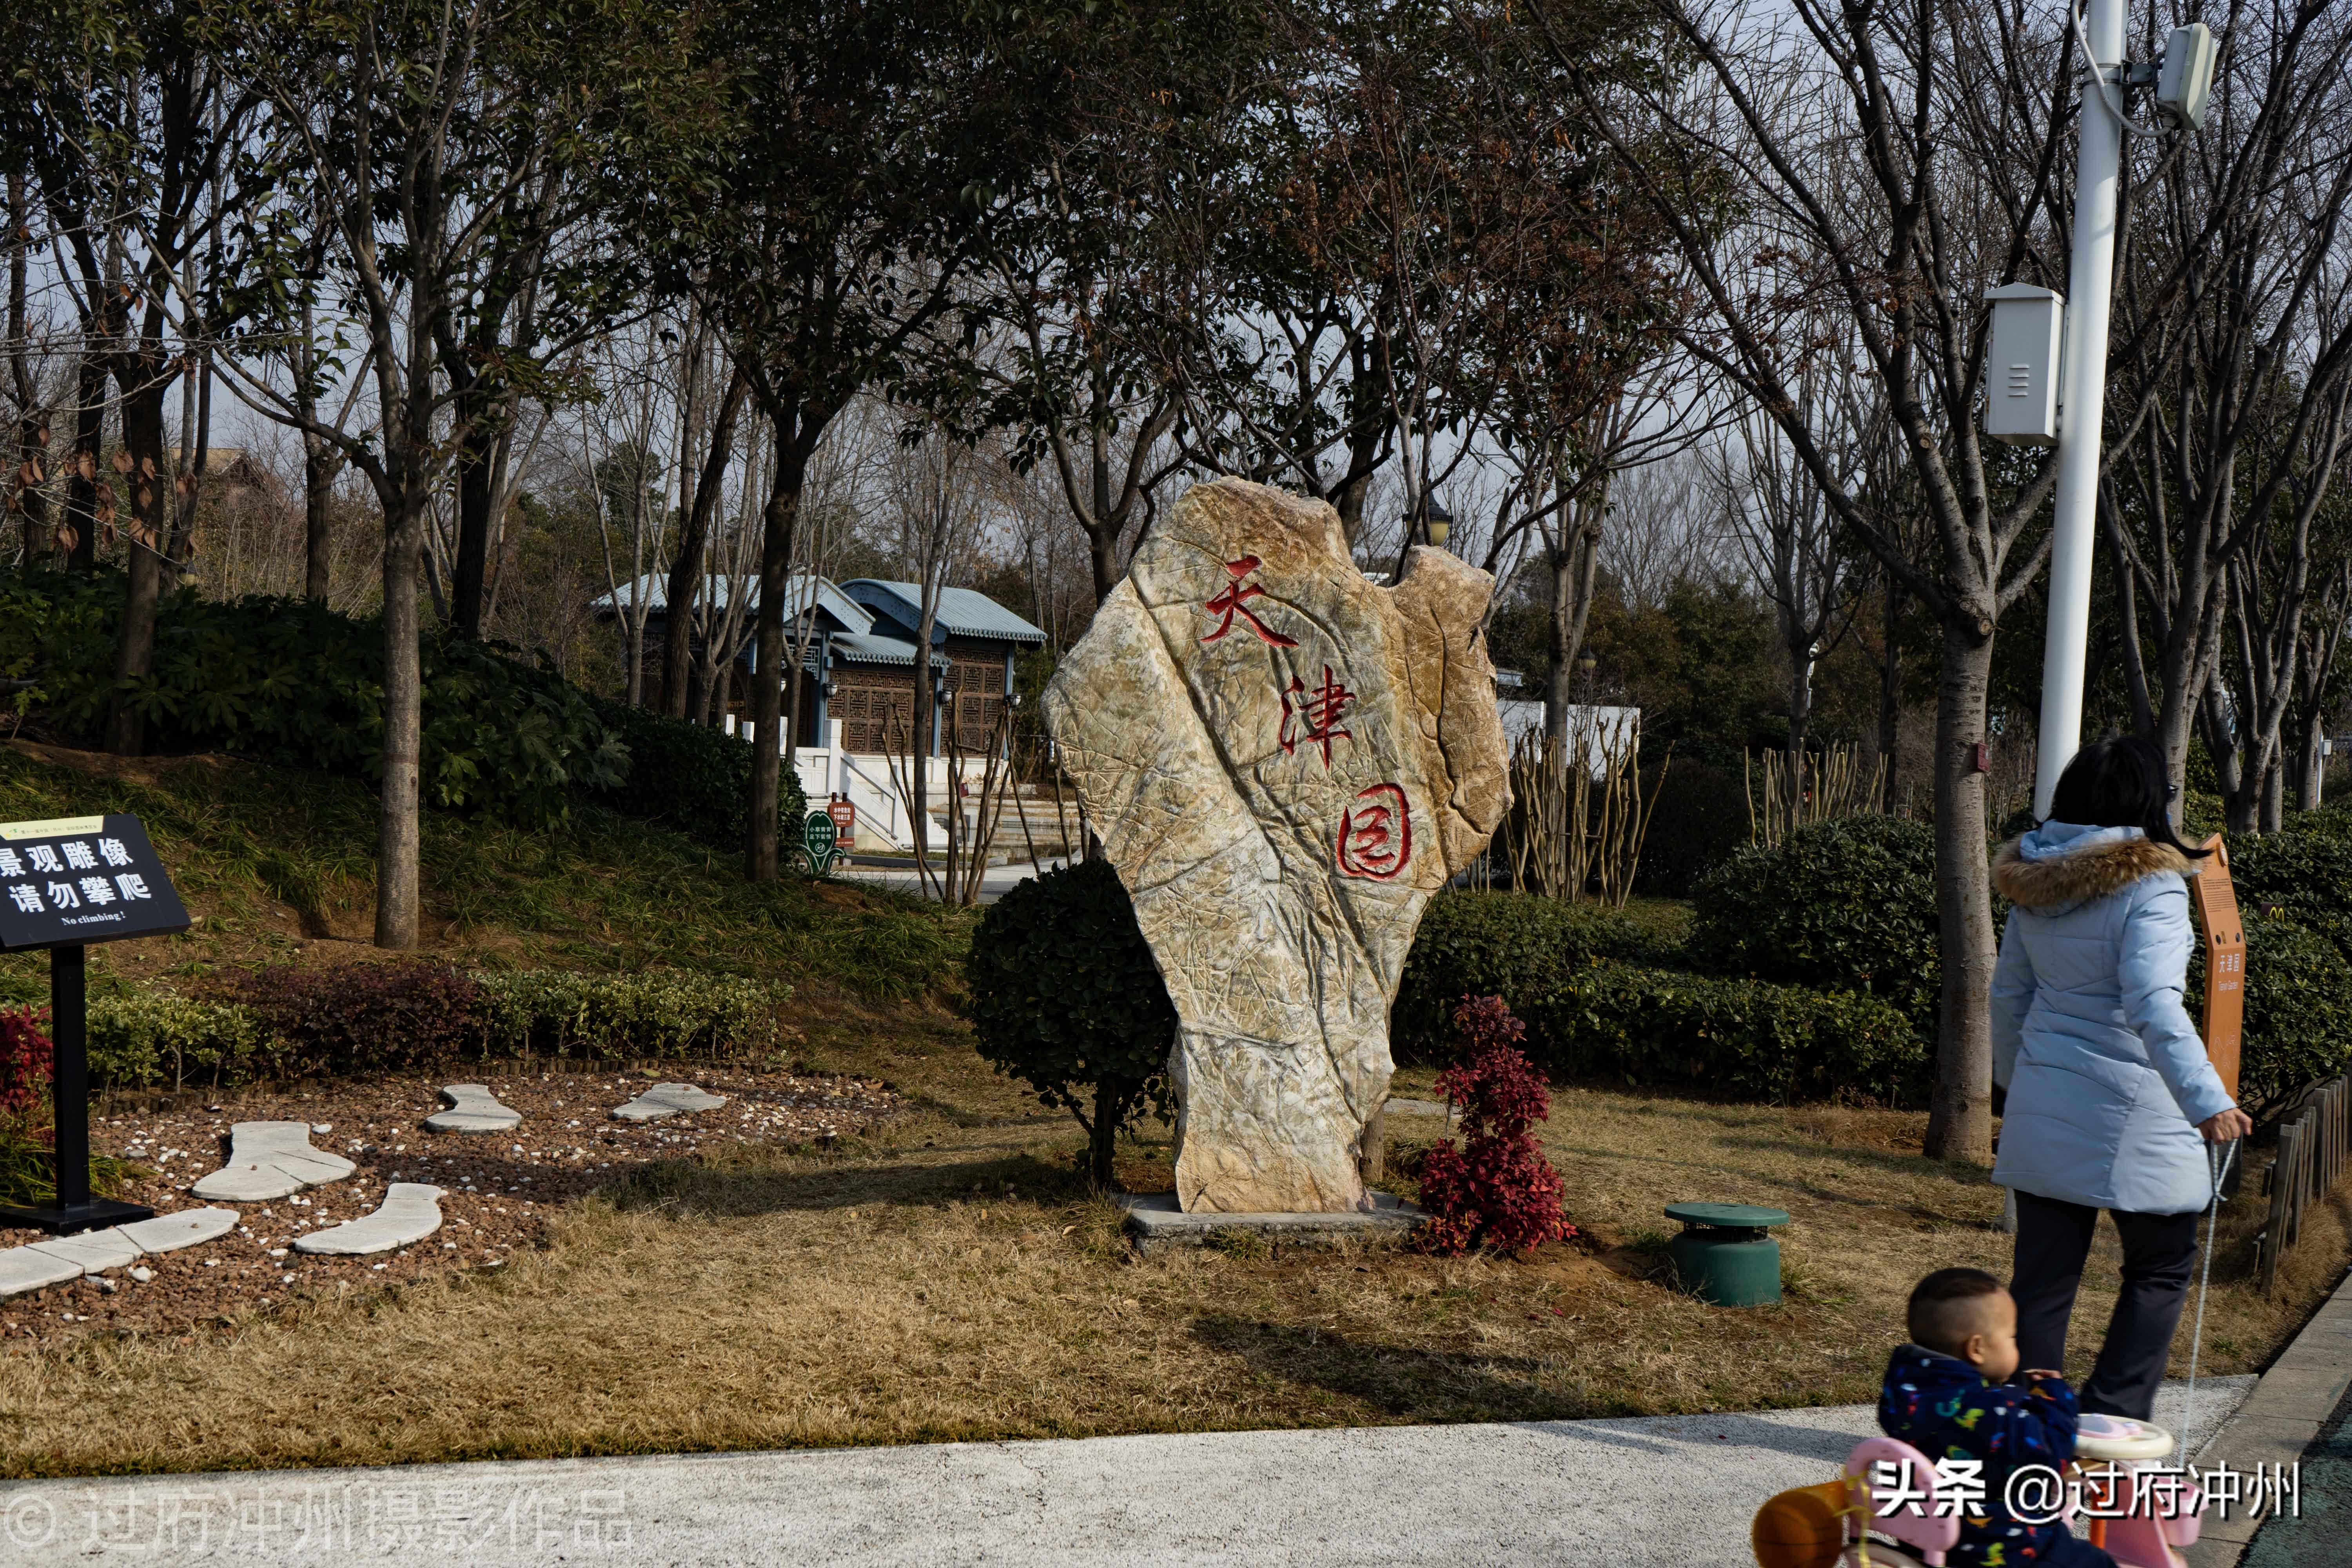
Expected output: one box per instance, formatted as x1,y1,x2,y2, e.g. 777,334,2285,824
2034,0,2124,816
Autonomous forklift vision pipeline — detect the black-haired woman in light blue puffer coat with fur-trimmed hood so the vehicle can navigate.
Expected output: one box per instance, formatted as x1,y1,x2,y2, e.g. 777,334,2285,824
1992,736,2253,1420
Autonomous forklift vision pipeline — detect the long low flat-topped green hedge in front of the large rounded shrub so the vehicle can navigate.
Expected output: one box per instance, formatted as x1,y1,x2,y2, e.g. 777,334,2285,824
1515,964,1929,1105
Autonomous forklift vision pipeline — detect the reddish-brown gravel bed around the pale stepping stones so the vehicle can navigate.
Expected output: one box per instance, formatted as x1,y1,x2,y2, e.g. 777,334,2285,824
0,1067,906,1354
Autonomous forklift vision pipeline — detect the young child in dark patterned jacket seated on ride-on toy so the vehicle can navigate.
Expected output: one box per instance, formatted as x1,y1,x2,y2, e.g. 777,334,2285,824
1879,1269,2114,1568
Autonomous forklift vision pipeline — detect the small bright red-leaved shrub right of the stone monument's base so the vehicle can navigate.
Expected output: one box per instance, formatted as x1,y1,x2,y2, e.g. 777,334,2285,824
1414,997,1576,1258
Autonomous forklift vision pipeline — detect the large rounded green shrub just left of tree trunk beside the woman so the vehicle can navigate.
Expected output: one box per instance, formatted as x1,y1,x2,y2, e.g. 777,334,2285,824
1691,816,1943,1032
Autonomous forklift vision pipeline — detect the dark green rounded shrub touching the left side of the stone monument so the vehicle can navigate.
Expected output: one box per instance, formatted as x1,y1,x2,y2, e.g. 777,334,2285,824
964,860,1176,1187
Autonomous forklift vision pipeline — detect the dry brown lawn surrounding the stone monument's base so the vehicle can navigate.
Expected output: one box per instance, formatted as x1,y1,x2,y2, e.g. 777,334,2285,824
0,1016,2345,1474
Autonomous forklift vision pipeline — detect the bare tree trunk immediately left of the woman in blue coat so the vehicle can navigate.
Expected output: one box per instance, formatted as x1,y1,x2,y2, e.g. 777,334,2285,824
1926,616,1994,1164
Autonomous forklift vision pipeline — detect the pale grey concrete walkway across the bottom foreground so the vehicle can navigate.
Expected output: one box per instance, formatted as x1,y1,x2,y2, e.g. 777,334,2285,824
0,1377,2253,1568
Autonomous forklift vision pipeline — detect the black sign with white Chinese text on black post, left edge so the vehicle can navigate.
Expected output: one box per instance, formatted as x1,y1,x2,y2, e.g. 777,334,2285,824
0,816,188,1236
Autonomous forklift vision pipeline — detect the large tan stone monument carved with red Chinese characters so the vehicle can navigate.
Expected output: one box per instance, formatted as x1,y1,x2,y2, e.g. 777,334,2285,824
1044,479,1510,1213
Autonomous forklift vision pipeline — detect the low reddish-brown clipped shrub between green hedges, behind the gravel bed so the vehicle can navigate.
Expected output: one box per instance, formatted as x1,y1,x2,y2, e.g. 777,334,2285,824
226,962,489,1077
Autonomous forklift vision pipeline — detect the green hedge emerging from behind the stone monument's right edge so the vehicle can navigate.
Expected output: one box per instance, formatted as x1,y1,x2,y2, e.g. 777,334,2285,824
1388,891,1677,1063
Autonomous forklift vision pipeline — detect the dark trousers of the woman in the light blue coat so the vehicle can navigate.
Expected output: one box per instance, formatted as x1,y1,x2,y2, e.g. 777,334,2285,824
2009,1192,2204,1420
